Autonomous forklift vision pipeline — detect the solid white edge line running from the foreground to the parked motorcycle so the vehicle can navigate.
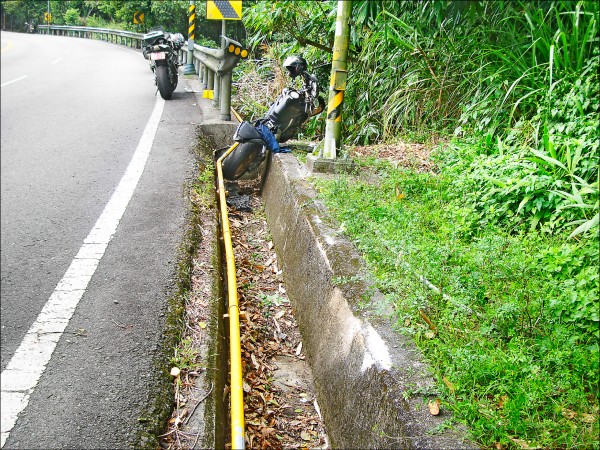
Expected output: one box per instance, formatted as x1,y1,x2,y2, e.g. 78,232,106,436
0,96,165,447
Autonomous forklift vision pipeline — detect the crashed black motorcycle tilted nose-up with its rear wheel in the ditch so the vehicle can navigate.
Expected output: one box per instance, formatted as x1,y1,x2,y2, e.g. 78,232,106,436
222,56,325,180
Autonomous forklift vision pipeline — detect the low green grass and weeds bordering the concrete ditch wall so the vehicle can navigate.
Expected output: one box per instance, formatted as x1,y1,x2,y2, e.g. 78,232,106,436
315,156,599,448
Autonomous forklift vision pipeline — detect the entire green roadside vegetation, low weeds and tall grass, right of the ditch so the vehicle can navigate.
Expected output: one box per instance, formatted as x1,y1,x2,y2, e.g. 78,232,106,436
239,1,600,449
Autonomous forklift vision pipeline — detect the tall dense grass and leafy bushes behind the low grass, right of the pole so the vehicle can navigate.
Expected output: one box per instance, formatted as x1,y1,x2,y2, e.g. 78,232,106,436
346,1,600,238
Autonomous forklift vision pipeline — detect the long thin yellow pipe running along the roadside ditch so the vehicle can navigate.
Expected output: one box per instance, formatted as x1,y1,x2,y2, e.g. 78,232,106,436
217,142,245,449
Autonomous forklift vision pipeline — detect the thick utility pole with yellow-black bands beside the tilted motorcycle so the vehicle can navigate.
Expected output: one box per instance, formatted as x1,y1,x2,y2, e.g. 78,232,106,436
323,0,352,159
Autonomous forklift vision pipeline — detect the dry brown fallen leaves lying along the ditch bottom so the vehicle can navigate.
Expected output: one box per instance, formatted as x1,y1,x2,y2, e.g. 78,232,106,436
230,185,326,448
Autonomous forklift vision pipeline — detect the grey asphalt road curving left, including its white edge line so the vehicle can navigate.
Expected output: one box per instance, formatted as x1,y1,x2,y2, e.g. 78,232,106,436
0,32,202,449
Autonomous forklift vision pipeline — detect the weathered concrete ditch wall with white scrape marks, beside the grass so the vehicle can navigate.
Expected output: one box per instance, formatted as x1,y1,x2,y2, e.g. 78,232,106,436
263,154,476,449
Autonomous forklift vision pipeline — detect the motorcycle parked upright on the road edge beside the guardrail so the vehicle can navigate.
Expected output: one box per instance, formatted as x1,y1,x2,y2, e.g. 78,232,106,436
142,29,185,100
